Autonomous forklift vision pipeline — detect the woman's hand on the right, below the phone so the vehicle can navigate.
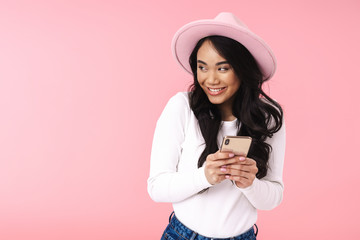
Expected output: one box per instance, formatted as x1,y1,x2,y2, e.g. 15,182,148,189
224,156,258,188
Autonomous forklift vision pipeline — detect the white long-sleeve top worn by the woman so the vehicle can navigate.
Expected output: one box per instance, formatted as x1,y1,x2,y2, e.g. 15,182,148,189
148,92,285,238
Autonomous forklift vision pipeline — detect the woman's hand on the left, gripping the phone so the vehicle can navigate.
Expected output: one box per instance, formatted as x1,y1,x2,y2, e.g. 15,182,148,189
205,151,239,185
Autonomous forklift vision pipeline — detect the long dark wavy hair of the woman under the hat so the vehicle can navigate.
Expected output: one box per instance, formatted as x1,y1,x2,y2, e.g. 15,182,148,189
189,36,283,179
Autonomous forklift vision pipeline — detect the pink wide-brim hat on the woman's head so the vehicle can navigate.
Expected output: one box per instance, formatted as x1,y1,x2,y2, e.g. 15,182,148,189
171,12,276,80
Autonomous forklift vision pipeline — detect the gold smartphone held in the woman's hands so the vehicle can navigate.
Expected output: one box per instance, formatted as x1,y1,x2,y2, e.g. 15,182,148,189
220,136,252,157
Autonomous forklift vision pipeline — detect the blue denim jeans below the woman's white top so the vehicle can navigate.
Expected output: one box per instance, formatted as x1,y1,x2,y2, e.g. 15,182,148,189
161,213,257,240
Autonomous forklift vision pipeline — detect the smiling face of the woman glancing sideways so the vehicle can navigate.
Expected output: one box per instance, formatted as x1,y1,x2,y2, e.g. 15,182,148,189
197,41,240,111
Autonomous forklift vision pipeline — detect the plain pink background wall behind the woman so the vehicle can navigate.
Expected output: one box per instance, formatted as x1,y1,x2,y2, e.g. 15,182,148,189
0,0,360,240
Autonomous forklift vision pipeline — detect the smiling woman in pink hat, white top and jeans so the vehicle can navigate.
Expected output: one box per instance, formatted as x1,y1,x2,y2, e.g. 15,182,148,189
148,13,285,239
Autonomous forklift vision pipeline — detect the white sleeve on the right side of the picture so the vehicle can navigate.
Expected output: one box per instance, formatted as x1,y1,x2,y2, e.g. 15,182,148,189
239,118,286,210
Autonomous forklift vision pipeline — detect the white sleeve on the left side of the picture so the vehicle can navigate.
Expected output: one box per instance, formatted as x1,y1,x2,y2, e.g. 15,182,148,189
147,93,211,203
